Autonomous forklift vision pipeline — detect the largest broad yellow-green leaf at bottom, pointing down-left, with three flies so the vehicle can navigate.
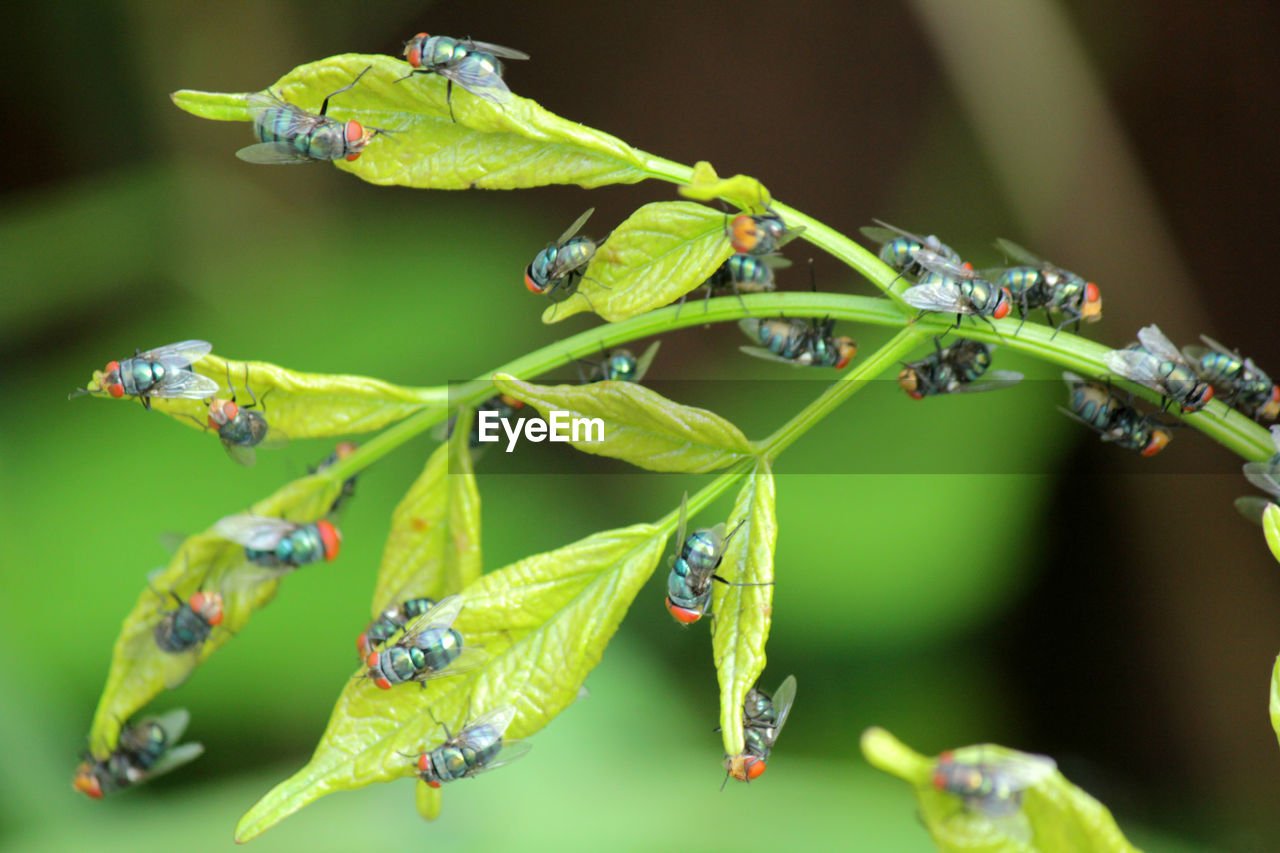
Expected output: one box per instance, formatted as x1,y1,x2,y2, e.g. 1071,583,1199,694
236,520,675,841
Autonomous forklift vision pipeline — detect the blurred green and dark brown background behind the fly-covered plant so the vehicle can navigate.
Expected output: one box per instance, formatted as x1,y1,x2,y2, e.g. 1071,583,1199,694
0,0,1280,852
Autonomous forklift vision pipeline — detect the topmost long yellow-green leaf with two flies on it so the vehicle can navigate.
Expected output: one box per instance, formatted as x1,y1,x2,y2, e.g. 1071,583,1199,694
172,54,649,190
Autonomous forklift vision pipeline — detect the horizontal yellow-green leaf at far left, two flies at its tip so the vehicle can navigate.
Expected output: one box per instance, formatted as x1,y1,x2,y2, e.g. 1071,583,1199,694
86,353,444,439
